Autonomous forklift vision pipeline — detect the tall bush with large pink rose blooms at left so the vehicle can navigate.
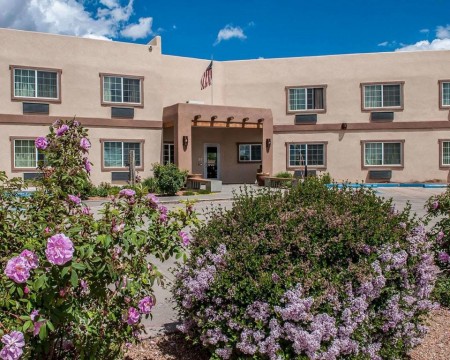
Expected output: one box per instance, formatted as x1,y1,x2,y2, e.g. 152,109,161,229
0,120,196,359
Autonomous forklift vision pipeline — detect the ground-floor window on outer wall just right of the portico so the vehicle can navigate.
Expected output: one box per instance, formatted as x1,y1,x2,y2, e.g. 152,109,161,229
287,143,325,168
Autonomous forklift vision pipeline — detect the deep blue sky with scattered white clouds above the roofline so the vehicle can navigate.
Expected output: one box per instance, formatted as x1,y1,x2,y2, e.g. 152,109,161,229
0,0,450,60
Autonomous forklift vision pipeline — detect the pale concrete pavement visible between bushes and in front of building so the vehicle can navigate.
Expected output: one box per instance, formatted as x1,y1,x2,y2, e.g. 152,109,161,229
86,185,446,337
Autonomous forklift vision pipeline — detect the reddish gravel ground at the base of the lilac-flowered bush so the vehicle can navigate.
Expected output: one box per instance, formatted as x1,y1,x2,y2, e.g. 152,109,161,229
125,309,450,360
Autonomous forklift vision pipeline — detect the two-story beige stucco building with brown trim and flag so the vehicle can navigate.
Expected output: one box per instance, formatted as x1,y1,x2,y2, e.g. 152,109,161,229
0,29,450,183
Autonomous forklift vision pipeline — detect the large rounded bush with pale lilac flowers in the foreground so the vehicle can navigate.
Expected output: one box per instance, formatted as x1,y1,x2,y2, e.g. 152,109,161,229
173,178,436,360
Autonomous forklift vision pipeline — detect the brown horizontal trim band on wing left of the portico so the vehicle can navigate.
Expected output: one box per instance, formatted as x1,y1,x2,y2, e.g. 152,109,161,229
0,114,162,129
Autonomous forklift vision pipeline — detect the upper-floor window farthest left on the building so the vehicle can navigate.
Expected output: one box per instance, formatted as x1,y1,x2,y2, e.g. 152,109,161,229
12,67,61,101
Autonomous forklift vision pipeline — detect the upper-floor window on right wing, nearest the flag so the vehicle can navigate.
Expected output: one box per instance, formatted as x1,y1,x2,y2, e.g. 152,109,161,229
287,86,325,112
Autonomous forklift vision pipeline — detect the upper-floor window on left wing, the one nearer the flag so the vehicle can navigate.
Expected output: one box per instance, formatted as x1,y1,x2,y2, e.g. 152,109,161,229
101,74,144,106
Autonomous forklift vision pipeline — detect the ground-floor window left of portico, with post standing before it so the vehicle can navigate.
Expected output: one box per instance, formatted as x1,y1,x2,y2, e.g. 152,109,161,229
103,141,142,168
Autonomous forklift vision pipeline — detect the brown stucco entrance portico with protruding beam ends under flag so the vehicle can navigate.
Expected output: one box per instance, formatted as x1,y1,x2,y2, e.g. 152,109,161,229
163,103,273,183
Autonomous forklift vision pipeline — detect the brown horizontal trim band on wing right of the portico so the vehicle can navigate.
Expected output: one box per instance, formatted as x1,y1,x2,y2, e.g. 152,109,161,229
273,120,450,133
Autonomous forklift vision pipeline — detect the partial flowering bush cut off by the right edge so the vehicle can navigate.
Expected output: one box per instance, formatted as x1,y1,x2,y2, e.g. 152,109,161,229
426,189,450,307
